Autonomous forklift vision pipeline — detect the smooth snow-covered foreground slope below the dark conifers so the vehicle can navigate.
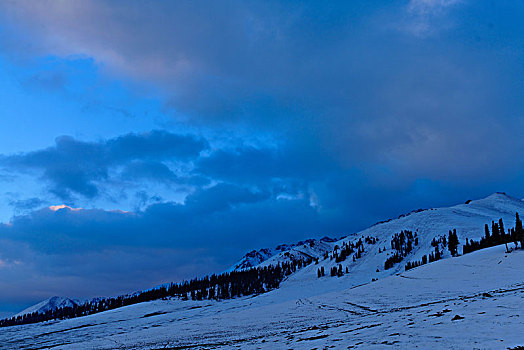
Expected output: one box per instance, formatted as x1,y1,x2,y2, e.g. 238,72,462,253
0,246,524,349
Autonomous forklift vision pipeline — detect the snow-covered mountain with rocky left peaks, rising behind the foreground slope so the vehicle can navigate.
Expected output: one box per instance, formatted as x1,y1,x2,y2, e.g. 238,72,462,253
232,192,524,280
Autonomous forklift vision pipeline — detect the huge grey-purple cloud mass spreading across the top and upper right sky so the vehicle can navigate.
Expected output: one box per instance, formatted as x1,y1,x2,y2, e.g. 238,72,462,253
3,0,524,180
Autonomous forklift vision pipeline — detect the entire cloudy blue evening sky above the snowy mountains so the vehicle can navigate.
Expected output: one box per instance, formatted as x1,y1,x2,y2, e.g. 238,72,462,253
0,0,524,316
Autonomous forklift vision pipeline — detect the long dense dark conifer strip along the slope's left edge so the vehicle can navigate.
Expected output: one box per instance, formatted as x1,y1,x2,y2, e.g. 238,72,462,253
0,259,313,327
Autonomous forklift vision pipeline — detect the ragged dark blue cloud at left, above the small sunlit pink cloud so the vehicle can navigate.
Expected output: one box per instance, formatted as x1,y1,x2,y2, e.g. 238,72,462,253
0,130,208,200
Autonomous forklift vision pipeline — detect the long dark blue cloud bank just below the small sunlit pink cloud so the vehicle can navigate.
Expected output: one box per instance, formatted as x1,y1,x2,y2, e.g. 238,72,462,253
1,184,318,254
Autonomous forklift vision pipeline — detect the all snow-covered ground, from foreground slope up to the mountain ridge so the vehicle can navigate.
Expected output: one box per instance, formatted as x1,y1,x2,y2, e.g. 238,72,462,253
7,193,524,349
